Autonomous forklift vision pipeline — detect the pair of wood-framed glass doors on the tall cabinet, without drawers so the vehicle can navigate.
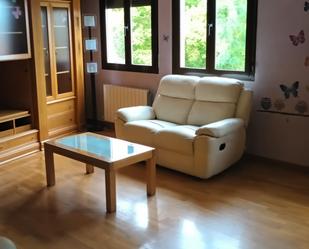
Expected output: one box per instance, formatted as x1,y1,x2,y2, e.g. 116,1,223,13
41,2,74,101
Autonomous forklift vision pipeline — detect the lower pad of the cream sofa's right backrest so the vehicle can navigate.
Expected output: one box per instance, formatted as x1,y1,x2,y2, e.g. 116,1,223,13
187,101,236,125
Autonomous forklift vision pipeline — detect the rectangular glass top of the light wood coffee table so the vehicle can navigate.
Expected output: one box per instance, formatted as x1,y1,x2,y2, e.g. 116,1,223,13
54,132,153,161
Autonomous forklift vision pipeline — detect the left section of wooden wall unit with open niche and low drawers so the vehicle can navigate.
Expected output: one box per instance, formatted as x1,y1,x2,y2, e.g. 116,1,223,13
0,0,40,165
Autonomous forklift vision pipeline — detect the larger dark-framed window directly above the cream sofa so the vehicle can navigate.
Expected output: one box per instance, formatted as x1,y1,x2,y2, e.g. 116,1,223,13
173,0,257,79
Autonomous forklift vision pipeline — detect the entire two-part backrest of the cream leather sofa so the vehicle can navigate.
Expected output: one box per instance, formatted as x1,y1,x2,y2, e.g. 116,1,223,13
153,75,252,126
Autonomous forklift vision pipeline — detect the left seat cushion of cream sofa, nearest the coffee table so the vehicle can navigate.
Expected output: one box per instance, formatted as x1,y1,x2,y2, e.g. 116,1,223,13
123,120,176,146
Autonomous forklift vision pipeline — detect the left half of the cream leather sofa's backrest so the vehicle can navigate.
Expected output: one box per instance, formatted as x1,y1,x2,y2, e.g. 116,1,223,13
153,75,200,124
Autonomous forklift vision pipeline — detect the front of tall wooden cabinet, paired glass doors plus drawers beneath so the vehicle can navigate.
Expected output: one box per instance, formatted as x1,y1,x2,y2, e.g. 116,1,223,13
41,2,77,137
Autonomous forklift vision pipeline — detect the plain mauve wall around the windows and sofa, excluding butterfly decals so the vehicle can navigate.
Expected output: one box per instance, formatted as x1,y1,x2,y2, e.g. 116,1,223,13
82,0,309,166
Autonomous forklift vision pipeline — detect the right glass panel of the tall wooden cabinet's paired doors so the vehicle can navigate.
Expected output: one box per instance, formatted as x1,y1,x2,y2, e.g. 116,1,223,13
53,7,73,94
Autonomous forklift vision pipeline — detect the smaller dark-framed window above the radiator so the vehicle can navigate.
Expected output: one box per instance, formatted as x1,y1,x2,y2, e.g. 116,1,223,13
101,0,158,73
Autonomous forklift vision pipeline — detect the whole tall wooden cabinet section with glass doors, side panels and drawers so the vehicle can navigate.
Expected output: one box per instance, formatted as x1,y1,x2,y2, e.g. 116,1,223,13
31,0,84,141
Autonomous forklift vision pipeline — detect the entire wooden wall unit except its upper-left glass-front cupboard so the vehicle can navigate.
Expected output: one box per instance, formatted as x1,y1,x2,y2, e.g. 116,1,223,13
0,0,84,164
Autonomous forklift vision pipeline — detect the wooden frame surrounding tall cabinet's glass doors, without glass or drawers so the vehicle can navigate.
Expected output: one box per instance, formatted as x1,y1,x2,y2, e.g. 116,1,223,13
30,0,85,142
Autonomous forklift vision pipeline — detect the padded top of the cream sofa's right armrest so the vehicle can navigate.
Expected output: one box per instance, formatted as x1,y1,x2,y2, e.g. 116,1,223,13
195,118,245,137
